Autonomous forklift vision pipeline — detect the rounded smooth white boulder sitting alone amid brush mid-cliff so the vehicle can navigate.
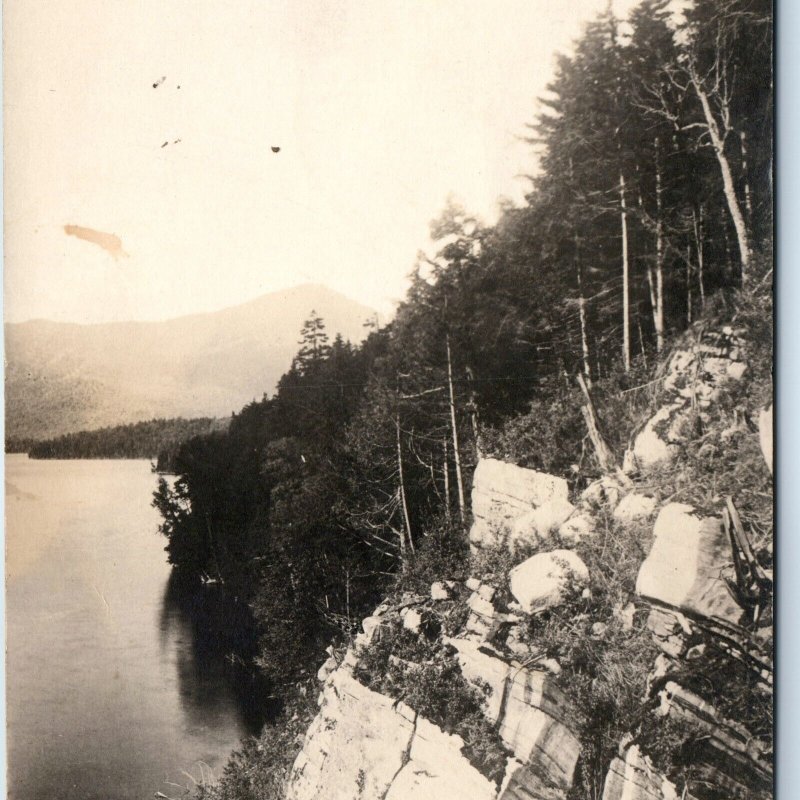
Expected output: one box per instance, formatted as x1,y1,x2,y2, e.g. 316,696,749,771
509,550,589,614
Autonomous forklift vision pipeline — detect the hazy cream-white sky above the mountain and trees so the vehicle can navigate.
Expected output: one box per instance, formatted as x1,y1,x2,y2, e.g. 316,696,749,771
4,0,635,322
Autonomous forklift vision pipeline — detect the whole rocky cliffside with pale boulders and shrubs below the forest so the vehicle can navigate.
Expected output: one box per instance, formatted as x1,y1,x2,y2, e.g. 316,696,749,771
287,327,772,800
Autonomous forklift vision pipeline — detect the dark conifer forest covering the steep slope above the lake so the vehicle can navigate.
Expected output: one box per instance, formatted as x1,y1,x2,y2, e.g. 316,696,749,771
150,0,772,681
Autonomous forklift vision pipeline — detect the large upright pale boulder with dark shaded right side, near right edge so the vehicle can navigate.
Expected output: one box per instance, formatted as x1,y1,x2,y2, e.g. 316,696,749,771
636,503,744,625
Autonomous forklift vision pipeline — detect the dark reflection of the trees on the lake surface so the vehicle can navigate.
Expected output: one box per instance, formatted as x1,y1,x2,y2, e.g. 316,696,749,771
159,570,277,735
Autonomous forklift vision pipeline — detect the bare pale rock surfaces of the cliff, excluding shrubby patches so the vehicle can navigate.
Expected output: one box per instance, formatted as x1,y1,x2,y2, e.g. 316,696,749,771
288,330,772,800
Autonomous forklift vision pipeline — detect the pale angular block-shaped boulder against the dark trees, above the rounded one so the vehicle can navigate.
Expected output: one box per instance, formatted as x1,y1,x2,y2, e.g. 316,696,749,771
470,458,569,548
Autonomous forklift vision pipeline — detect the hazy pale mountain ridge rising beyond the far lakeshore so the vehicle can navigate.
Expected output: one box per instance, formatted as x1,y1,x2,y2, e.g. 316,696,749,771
5,284,375,439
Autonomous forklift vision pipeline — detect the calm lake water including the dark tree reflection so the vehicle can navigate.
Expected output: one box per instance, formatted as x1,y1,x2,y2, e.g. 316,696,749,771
5,456,262,800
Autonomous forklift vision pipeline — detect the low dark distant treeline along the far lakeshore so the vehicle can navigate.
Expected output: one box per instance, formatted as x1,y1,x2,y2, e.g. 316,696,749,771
25,417,229,462
